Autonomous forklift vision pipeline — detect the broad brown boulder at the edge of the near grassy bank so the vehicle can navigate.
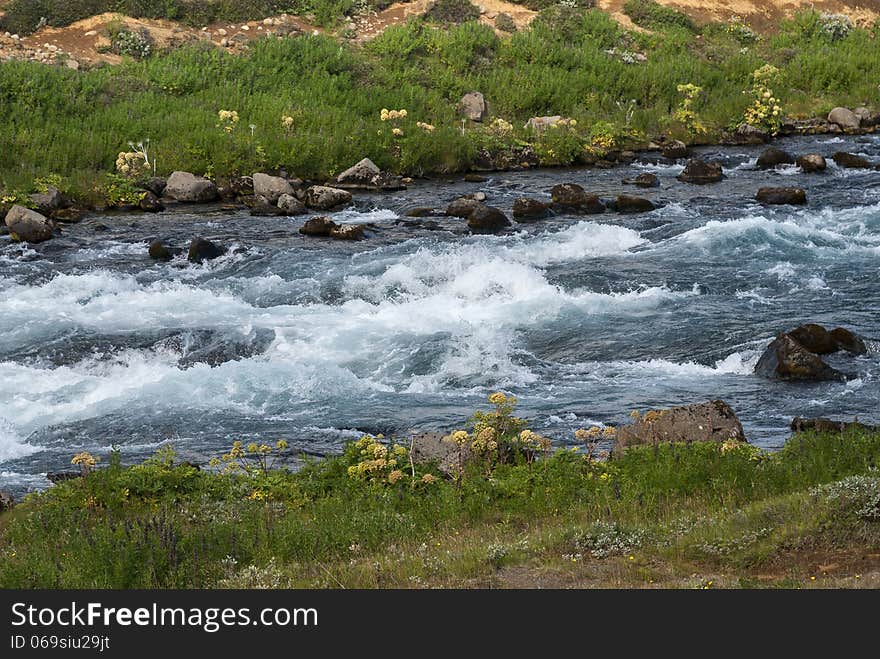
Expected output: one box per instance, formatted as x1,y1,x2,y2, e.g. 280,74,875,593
614,400,747,453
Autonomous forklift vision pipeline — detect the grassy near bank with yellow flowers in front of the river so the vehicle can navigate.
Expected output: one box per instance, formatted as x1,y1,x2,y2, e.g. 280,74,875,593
0,394,880,588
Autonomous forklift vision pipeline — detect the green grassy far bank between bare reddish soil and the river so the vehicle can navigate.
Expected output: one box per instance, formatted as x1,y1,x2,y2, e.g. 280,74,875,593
0,5,880,203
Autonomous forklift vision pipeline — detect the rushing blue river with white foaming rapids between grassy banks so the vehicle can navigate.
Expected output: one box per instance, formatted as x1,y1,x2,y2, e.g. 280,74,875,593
0,136,880,492
